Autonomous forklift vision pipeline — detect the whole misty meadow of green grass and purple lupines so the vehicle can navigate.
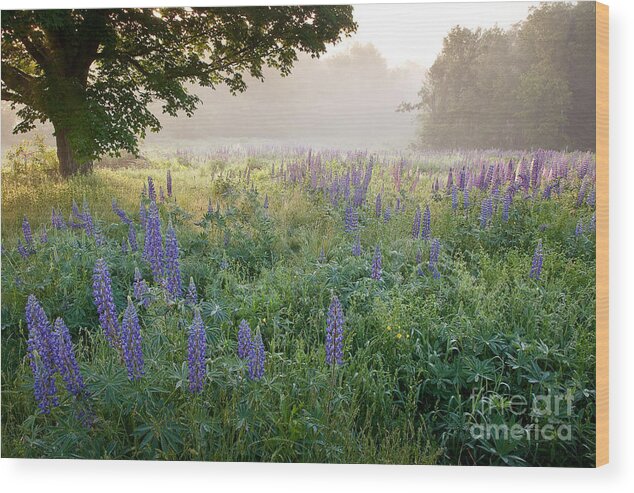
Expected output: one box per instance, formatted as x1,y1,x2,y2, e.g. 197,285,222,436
2,147,595,466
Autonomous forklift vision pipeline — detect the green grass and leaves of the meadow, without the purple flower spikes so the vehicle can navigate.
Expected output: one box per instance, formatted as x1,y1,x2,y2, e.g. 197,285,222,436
2,146,595,466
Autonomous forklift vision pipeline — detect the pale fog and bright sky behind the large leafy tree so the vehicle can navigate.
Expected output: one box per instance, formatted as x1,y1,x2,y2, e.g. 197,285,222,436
2,2,537,151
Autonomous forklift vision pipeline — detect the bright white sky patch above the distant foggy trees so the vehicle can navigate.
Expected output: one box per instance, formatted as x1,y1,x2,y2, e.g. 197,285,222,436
329,2,539,67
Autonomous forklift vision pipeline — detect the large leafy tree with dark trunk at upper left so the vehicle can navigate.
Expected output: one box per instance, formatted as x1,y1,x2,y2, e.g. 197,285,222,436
2,6,356,176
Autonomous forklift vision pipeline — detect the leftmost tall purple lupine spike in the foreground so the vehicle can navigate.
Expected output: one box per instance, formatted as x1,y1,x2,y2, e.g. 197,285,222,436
26,294,59,414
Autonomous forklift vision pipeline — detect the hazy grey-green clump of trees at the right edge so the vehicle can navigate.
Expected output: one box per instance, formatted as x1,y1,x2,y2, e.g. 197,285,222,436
403,2,596,150
